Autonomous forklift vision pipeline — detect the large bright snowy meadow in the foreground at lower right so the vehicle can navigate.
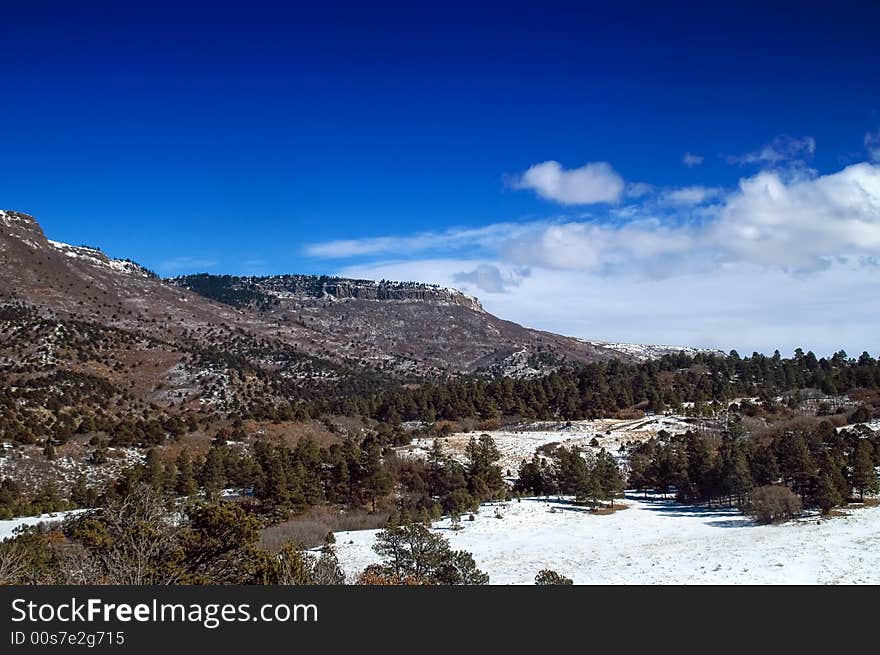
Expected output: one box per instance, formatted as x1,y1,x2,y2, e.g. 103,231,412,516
336,496,880,584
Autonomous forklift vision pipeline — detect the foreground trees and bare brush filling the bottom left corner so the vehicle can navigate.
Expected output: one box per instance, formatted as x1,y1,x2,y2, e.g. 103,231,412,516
0,484,345,585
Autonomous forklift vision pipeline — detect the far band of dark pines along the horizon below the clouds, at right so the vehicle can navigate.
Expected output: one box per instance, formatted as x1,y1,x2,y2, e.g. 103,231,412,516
352,349,880,423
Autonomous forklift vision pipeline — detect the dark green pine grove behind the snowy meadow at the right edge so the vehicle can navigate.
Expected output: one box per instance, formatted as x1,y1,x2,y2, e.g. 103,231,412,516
629,420,880,512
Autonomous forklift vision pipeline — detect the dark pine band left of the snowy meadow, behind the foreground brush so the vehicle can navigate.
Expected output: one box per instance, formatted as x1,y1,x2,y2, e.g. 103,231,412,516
99,426,508,521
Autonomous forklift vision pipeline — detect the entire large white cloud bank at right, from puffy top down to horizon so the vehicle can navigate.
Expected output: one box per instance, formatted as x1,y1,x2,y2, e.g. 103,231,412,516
316,163,880,353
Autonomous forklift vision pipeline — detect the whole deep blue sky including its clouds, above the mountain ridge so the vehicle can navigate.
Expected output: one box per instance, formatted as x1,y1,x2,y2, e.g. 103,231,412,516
0,1,880,353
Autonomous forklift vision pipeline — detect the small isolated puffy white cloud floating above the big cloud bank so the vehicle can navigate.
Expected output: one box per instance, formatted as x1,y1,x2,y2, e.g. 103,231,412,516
512,161,624,205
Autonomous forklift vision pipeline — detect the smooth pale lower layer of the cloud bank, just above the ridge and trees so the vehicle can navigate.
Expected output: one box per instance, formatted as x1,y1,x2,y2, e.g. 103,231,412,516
337,260,880,356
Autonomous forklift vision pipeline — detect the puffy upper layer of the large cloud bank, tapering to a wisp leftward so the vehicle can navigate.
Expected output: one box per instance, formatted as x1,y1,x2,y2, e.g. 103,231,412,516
307,163,880,278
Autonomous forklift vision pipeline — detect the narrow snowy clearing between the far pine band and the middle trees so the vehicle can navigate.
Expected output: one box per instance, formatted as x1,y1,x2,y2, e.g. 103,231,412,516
397,415,692,475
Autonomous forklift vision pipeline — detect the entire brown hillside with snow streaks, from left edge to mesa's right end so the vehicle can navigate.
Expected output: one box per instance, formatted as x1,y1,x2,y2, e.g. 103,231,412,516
0,211,632,422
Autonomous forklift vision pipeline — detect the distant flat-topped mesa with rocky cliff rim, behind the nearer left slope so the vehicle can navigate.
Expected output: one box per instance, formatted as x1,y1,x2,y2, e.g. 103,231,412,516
169,274,627,377
